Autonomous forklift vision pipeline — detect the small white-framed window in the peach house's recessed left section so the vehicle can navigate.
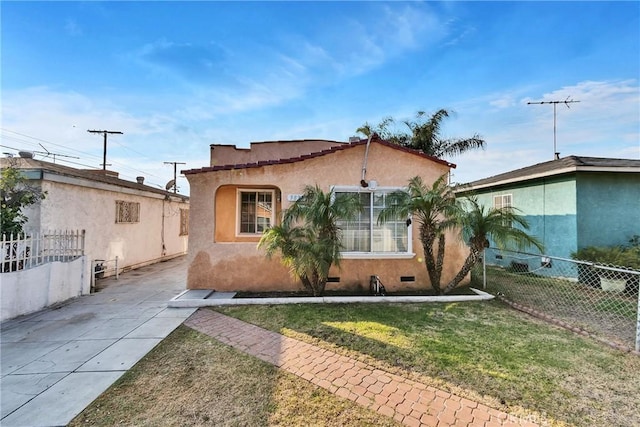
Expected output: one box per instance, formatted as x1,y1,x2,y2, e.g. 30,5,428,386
237,188,275,235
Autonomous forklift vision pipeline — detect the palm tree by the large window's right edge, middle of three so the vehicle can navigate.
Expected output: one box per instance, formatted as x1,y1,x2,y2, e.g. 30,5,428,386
378,174,462,295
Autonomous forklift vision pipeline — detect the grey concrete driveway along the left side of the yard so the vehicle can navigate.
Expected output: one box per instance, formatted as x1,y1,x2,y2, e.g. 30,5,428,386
0,257,195,427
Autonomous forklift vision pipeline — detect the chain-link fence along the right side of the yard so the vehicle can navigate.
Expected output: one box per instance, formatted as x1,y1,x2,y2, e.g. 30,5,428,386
472,248,640,351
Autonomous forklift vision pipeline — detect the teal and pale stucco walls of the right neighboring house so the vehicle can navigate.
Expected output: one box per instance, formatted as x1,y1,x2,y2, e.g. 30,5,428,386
464,172,640,258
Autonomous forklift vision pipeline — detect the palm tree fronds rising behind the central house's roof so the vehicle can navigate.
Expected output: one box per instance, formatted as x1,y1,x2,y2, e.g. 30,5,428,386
356,108,486,158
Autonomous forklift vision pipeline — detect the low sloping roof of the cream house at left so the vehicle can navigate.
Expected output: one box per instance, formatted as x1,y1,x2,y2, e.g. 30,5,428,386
0,157,189,200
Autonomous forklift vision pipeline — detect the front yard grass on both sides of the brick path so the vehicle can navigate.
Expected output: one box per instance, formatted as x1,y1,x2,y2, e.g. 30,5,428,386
71,301,640,426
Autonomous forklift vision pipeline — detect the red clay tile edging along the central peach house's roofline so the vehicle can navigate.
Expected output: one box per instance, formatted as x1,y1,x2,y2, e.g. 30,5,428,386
181,137,456,175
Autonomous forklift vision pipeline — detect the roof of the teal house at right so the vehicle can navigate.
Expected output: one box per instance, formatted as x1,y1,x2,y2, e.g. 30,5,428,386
458,156,640,192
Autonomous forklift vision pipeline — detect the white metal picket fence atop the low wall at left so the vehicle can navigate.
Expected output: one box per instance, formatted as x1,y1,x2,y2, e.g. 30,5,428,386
0,230,85,273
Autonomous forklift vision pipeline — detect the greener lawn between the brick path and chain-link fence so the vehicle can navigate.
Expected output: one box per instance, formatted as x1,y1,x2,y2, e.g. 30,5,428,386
218,301,640,425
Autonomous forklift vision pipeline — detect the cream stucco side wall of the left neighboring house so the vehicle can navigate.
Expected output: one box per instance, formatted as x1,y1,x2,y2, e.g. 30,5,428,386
26,180,189,274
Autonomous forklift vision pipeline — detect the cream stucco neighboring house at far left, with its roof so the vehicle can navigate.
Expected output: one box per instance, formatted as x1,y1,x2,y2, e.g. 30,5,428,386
1,158,189,290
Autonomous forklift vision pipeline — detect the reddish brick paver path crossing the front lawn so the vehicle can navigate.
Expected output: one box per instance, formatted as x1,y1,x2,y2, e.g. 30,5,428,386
185,309,537,427
